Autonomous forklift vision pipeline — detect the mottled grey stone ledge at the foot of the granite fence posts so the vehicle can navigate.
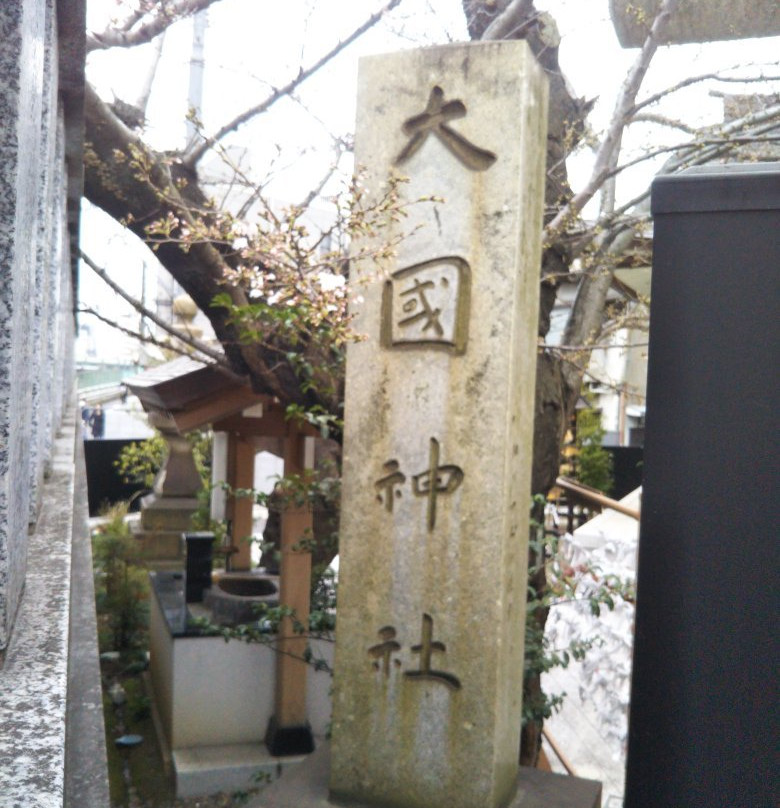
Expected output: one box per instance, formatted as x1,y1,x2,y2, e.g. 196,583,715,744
0,409,109,808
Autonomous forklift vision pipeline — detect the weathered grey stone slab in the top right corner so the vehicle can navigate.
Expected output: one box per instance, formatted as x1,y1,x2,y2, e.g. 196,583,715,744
609,0,780,48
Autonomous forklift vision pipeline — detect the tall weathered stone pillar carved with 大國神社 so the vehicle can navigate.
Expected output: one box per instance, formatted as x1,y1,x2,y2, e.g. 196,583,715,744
330,42,547,808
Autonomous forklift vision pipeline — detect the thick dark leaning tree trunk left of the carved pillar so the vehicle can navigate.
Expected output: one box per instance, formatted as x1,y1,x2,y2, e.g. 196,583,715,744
84,85,341,413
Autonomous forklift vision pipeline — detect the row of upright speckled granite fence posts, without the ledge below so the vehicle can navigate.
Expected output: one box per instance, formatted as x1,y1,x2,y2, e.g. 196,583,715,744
0,0,73,652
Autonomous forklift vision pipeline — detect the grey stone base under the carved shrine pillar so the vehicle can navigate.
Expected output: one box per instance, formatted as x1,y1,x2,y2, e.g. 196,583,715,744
247,742,601,808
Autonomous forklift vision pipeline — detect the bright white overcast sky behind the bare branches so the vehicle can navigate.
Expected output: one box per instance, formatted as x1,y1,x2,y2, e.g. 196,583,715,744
82,0,780,362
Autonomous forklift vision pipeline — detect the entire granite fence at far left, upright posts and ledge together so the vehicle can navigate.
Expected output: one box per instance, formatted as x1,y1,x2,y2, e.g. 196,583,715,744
0,0,109,808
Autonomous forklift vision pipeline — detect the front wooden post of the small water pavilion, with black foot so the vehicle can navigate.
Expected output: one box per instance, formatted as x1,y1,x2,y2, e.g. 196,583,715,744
266,425,314,756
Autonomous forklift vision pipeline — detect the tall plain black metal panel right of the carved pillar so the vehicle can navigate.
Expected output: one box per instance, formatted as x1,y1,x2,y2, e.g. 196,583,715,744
625,166,780,808
